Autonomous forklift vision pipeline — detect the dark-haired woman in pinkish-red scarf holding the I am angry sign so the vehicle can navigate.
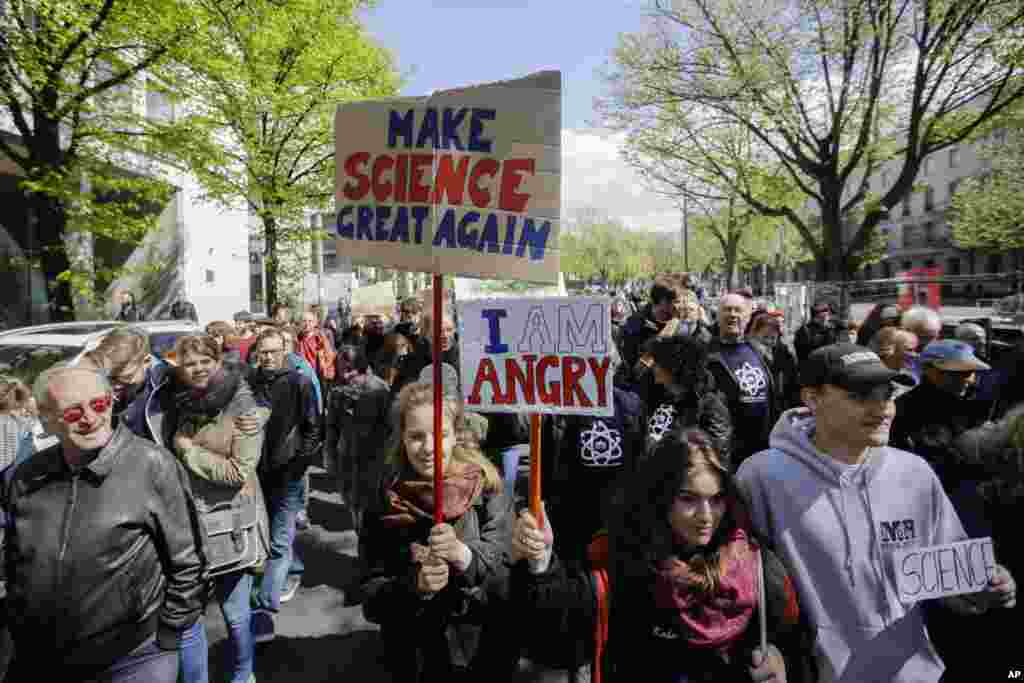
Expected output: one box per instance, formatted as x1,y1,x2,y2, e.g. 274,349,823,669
511,430,813,683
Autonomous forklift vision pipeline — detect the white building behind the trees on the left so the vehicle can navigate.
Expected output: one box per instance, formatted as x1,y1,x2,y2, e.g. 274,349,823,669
0,76,251,327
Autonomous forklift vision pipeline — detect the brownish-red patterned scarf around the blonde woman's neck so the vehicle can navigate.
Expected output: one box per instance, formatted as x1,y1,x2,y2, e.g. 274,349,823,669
382,460,483,527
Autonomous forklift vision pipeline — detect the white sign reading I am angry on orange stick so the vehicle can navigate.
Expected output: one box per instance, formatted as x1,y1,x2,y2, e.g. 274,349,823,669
459,297,614,417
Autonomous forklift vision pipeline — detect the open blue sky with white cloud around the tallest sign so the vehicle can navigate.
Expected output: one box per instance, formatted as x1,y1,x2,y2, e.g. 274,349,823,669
365,0,679,231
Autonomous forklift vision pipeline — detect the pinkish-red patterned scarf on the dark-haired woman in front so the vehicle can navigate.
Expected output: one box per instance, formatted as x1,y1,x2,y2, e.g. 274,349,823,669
654,528,759,653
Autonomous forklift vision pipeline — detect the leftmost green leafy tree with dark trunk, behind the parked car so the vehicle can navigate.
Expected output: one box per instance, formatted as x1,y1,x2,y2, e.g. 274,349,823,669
0,0,212,319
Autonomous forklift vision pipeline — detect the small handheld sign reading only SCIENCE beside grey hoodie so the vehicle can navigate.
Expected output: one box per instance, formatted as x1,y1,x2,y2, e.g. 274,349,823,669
893,538,995,603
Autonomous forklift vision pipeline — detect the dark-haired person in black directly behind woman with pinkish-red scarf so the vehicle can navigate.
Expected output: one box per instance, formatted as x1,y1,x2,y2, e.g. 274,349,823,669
641,337,732,460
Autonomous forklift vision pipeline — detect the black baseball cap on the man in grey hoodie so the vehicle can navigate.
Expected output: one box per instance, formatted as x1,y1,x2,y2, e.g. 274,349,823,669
800,343,914,391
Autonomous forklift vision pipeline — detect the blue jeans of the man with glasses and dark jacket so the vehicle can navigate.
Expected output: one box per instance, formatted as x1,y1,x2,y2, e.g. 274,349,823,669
256,476,306,612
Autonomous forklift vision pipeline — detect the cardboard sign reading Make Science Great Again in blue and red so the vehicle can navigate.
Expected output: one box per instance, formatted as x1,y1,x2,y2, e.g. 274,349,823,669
333,72,561,283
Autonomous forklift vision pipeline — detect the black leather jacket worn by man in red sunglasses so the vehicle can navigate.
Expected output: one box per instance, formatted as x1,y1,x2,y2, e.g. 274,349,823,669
3,426,206,680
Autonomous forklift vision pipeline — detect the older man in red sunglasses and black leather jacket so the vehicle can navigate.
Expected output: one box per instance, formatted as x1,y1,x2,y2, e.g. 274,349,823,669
0,364,206,683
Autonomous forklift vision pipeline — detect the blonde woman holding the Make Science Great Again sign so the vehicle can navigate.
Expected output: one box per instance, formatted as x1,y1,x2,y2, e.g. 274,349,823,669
359,382,514,683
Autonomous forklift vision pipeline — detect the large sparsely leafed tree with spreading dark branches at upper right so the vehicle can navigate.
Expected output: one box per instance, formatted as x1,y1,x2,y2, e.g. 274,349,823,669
601,0,1024,280
